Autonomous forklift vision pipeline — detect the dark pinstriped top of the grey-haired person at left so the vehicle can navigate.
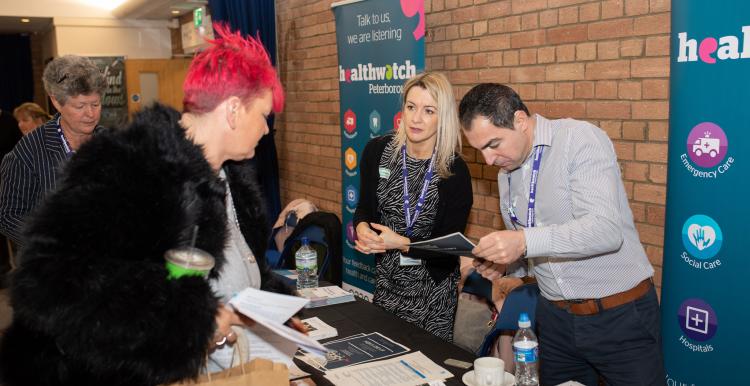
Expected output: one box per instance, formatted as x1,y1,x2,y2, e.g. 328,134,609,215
0,114,66,245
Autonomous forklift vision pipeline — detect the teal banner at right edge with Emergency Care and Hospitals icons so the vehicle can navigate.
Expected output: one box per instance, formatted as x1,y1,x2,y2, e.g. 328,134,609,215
662,0,750,386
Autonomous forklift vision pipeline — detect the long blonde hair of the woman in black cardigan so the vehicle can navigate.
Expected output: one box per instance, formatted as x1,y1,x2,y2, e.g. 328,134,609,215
393,72,461,178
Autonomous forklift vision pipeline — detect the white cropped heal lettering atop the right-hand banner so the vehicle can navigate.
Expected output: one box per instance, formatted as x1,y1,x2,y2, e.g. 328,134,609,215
677,25,750,64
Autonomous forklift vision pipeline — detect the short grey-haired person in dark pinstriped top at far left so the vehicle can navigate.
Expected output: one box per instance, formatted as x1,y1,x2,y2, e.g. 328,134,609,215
0,55,107,248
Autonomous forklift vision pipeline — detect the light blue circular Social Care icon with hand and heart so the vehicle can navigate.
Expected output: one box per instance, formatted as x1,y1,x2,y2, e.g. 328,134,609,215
682,214,724,260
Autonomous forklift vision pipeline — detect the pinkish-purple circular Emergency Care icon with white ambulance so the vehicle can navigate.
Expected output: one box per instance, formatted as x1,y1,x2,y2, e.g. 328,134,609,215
687,122,729,168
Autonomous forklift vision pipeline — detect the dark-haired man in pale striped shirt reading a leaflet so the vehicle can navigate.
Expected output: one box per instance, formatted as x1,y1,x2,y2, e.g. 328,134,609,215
459,84,665,385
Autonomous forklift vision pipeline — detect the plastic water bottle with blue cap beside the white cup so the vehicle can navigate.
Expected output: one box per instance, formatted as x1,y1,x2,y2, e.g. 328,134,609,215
513,312,539,386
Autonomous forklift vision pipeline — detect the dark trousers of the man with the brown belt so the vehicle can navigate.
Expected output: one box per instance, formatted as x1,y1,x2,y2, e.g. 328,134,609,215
536,287,666,386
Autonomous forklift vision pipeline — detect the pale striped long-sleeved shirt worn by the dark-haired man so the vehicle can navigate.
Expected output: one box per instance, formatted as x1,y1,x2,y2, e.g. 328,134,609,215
498,115,654,300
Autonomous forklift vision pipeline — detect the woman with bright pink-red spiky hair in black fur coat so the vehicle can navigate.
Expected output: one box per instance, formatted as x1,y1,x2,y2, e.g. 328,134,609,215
0,25,284,386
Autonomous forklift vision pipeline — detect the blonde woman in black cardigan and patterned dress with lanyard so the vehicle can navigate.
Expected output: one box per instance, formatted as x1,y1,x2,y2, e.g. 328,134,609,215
354,72,473,341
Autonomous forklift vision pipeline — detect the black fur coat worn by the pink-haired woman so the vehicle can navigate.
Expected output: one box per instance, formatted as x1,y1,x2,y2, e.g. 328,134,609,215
0,105,280,386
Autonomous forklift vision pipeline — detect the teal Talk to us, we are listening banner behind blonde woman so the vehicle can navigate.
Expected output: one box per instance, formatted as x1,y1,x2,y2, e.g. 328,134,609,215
331,0,425,301
